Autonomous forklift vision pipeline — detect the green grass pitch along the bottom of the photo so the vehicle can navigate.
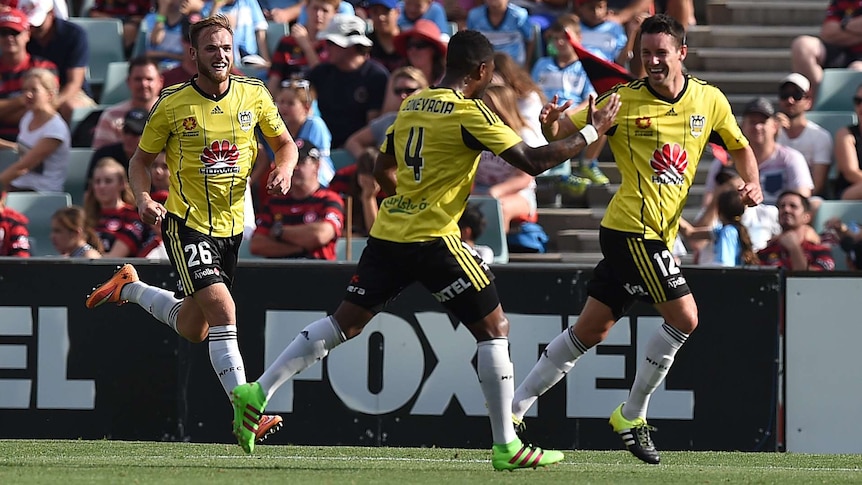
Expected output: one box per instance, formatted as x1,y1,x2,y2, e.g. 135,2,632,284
0,440,862,485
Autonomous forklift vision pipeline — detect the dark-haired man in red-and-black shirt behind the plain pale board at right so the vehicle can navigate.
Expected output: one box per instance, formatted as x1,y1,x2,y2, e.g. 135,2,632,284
757,190,835,271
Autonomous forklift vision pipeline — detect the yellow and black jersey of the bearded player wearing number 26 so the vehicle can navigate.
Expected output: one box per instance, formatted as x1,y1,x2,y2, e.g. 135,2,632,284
138,76,286,237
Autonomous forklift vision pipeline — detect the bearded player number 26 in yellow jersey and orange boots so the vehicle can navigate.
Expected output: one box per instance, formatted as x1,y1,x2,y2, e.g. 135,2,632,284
86,15,297,439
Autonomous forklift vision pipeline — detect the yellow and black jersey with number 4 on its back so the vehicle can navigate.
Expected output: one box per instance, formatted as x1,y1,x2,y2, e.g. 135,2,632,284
371,88,521,242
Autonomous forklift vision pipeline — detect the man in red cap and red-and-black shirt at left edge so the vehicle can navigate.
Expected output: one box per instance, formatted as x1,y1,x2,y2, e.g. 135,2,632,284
0,9,57,142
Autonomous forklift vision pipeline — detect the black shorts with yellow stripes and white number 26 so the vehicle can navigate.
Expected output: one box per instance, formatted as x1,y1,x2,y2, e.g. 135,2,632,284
162,214,242,299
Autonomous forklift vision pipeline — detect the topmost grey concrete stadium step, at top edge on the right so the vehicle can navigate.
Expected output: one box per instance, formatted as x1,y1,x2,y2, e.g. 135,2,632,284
706,0,829,26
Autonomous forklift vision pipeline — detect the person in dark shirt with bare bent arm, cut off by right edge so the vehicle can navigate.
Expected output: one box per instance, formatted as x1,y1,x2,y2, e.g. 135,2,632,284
835,84,862,200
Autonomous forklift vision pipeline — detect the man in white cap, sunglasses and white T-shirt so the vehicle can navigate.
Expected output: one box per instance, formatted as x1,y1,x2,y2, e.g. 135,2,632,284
777,72,832,195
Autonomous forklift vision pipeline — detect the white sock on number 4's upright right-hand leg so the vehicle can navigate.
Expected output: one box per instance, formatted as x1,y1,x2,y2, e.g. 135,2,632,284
476,338,517,445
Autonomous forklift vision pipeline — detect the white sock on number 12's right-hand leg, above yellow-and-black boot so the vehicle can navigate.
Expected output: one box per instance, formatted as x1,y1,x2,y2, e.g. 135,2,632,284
622,323,688,420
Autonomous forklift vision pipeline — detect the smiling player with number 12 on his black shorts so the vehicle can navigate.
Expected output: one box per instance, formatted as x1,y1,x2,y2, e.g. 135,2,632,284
512,14,763,464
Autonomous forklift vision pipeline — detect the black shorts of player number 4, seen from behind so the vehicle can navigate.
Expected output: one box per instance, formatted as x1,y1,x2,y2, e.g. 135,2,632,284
344,236,500,324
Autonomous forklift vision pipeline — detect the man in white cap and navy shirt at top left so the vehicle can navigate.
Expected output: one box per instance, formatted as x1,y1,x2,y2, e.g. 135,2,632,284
18,0,96,120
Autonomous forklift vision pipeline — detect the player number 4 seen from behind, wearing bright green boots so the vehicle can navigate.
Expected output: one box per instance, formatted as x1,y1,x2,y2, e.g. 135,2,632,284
233,30,619,462
